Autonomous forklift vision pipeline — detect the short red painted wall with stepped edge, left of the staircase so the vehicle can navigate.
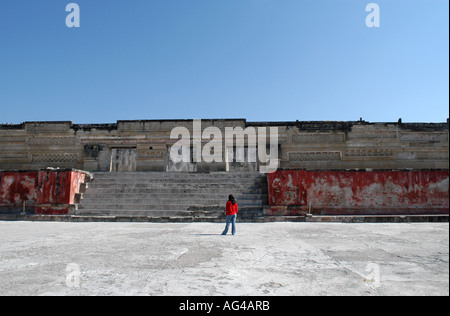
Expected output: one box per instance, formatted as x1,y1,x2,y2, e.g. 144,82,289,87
0,170,87,214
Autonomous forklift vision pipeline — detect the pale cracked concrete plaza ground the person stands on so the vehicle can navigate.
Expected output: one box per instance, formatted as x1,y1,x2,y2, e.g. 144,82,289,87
0,222,449,296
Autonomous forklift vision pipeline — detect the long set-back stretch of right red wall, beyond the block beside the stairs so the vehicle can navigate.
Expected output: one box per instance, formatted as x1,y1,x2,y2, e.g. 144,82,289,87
305,171,448,209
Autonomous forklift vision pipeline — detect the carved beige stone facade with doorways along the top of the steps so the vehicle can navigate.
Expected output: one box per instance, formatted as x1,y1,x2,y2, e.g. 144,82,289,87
0,119,449,172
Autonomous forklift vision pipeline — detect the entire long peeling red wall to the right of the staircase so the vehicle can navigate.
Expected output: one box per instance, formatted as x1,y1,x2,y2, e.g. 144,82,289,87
266,170,449,215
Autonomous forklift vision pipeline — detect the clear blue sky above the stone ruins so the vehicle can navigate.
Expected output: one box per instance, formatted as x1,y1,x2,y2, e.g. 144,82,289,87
0,0,449,123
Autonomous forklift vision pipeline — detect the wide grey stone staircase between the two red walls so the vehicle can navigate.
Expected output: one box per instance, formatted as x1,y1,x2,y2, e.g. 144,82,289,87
74,172,267,219
